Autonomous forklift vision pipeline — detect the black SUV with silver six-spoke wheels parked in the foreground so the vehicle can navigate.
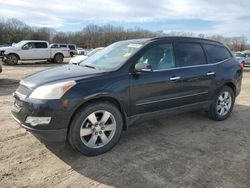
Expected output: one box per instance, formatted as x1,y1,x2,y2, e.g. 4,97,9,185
12,37,243,155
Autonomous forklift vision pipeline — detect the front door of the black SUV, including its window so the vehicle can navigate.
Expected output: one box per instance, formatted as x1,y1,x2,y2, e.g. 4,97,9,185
129,42,187,115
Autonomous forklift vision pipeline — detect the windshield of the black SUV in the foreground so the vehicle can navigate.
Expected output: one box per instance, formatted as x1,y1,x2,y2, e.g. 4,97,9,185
80,41,142,71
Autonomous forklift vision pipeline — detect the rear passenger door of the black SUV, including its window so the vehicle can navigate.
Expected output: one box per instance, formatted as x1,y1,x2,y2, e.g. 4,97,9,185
175,42,216,105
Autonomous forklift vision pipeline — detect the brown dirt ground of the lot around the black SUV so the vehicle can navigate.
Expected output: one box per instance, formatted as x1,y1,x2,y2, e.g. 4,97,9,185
0,60,250,188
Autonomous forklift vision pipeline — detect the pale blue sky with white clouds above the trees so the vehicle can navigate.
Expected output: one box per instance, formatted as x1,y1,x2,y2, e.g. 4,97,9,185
0,0,250,38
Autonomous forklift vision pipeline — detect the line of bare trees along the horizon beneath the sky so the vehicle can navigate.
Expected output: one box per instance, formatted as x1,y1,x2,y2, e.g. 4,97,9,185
0,18,250,51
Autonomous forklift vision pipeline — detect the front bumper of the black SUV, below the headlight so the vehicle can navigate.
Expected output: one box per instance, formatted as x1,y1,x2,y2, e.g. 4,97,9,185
11,95,71,142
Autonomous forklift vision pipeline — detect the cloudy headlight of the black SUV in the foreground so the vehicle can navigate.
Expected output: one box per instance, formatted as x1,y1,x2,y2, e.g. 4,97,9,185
29,81,76,99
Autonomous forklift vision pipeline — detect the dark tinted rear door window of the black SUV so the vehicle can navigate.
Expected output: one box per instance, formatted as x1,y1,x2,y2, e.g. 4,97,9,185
176,43,206,67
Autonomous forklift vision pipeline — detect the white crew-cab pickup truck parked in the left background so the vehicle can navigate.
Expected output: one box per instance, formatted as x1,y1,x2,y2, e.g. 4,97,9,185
0,40,70,65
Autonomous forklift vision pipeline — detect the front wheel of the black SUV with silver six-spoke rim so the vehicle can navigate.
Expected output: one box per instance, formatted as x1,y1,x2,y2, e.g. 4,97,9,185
68,102,123,156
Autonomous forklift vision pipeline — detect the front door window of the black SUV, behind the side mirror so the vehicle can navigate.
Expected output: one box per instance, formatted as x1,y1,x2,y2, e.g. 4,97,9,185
138,44,175,70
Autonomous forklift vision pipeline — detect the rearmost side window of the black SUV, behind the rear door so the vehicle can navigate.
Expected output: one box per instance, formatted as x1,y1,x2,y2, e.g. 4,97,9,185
203,44,232,63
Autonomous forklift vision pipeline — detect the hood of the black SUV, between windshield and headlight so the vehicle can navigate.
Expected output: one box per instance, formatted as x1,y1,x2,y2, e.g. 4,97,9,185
20,65,103,88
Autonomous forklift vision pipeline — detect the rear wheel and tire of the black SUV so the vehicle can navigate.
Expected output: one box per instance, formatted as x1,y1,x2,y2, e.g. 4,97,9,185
208,86,235,121
